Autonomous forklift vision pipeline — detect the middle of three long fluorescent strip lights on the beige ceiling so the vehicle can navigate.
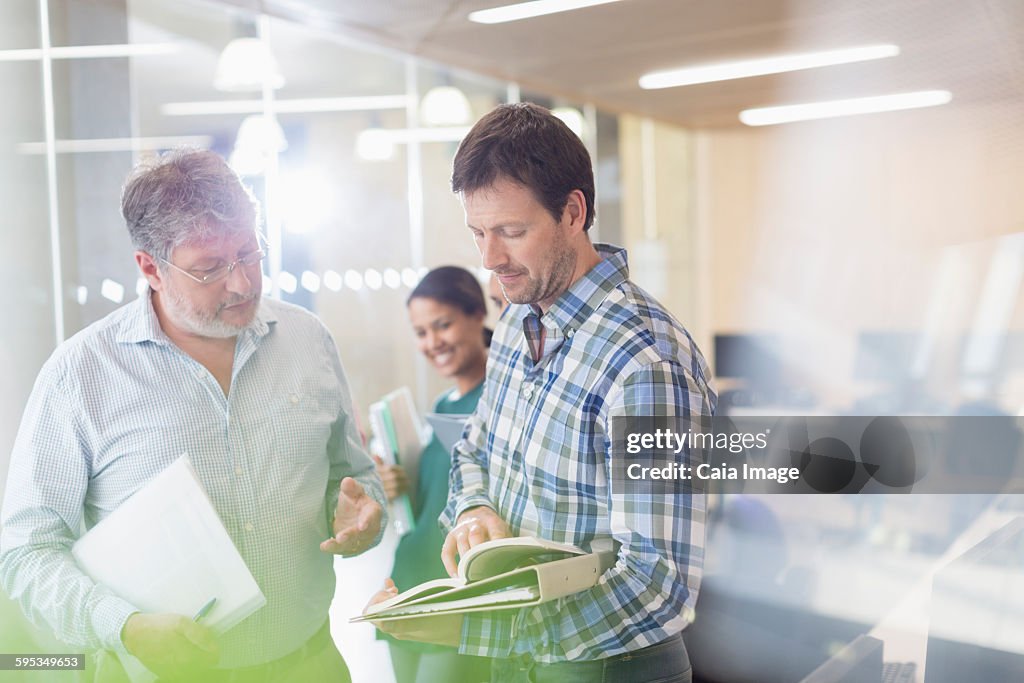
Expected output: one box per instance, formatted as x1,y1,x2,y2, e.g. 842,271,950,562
640,45,899,90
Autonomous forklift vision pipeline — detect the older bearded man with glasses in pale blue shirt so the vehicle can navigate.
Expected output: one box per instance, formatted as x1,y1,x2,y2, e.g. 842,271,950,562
0,151,384,681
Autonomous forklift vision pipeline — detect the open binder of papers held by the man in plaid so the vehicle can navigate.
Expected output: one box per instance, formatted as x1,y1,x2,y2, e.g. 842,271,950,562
349,537,615,622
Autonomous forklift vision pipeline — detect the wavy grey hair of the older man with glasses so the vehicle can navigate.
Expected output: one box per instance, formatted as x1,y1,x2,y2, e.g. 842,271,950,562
121,147,259,260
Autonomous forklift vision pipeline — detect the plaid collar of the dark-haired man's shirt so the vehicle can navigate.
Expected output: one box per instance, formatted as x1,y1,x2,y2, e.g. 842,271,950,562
510,243,630,334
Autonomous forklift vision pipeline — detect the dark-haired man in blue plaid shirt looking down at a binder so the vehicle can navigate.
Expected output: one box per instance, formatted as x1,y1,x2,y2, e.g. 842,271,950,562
372,103,716,683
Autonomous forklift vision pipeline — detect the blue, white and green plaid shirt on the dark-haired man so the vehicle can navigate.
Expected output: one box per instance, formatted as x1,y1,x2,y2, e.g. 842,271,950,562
440,245,716,663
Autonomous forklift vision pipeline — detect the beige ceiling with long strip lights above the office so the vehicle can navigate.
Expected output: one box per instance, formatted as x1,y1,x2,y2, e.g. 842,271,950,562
207,0,1024,127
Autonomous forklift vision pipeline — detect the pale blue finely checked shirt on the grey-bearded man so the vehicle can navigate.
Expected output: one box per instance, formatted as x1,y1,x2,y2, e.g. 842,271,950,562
0,296,384,668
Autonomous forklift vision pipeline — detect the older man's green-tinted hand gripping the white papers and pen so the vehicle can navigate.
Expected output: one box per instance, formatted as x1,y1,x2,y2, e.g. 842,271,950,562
121,612,220,681
